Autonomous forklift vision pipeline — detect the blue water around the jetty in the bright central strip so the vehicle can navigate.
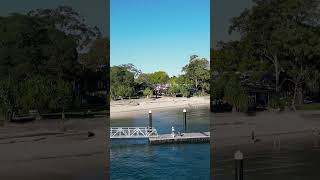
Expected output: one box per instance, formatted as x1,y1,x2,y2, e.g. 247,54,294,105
110,109,210,180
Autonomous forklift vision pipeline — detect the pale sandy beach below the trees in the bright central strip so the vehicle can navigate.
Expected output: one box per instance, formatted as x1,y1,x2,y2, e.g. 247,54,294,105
110,96,210,118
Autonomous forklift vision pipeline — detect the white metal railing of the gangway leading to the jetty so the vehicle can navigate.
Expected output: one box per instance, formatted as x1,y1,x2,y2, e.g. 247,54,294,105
110,127,158,139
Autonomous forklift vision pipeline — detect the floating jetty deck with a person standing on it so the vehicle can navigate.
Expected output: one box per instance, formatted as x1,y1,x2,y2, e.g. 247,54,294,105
149,132,210,144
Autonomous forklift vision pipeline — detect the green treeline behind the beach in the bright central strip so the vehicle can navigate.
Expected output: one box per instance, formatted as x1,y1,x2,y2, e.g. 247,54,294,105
110,55,210,99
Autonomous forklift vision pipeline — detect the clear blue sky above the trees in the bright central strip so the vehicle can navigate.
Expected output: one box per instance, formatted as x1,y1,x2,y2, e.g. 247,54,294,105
110,0,210,76
